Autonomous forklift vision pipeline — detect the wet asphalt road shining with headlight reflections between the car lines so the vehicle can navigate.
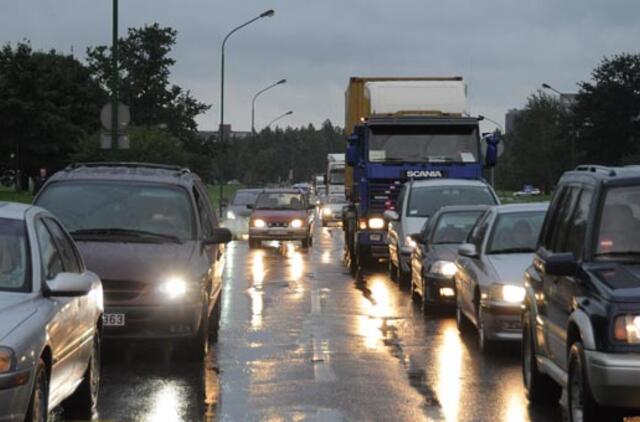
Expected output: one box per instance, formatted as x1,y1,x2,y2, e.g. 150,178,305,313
84,223,576,422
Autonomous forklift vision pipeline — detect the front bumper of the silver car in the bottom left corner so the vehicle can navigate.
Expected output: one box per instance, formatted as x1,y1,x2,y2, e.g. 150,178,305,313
0,369,33,422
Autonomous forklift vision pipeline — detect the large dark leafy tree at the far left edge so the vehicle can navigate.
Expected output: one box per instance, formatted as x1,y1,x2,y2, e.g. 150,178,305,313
0,42,107,186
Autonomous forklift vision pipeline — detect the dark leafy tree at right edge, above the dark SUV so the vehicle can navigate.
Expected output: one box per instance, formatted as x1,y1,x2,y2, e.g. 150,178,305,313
574,53,640,165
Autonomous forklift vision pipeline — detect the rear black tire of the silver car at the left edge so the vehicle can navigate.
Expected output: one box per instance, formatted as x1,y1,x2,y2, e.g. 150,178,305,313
62,333,102,419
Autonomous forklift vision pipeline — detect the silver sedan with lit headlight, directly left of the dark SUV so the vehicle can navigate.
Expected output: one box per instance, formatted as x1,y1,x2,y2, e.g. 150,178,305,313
455,203,548,353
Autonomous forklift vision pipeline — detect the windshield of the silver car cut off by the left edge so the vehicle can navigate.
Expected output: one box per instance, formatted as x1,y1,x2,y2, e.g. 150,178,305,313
0,218,29,292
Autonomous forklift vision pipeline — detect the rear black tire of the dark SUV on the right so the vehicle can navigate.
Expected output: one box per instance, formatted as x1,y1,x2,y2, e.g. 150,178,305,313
521,313,562,404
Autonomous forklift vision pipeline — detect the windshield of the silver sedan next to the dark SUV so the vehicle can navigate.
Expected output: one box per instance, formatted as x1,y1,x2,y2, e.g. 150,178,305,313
487,211,545,254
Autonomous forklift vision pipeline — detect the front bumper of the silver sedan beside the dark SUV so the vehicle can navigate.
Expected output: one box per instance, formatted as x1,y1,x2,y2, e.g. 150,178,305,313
480,301,522,341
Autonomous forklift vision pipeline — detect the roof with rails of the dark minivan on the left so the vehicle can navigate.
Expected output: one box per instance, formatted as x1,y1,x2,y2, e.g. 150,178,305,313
47,162,199,186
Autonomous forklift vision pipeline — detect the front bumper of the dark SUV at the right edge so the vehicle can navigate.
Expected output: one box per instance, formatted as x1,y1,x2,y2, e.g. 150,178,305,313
584,350,640,409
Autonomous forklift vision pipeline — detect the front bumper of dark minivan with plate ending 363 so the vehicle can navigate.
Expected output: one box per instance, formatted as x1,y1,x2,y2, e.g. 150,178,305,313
103,303,202,340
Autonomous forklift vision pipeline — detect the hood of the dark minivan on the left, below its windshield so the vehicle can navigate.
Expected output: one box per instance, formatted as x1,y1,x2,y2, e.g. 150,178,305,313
76,241,197,281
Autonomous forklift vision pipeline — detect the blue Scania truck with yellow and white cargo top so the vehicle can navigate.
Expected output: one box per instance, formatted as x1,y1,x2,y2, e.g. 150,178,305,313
343,76,499,275
